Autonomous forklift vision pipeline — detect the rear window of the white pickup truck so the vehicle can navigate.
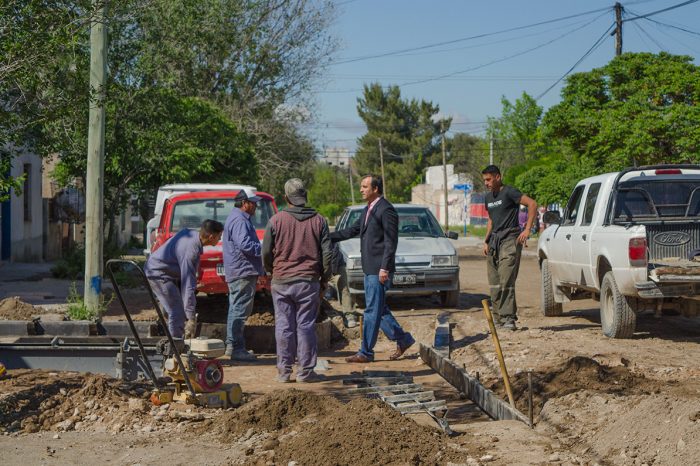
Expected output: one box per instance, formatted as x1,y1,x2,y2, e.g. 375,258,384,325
615,178,700,222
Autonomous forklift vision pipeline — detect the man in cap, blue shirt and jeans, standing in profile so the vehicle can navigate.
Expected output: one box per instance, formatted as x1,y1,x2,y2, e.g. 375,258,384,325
223,188,265,361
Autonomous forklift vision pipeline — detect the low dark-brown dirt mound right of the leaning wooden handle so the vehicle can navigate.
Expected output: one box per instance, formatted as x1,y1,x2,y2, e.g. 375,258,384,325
491,356,659,413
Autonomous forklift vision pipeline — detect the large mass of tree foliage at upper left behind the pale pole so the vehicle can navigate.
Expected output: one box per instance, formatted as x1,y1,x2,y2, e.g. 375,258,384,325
0,0,335,244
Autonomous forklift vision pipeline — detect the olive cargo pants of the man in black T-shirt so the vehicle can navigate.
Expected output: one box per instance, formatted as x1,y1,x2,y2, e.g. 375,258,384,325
486,235,523,323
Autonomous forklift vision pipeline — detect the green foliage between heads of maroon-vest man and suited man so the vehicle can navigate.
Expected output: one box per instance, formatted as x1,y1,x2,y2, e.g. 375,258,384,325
308,163,351,223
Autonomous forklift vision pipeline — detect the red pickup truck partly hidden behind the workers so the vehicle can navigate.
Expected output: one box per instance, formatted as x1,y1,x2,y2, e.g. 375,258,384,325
151,191,277,294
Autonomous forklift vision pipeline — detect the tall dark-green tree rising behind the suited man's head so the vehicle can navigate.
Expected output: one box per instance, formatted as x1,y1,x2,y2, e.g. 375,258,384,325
355,83,450,202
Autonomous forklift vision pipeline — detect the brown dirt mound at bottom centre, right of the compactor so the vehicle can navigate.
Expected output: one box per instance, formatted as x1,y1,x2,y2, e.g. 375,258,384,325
202,389,476,465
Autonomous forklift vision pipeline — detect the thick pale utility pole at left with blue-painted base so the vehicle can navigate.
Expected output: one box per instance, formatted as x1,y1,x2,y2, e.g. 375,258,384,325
83,0,107,313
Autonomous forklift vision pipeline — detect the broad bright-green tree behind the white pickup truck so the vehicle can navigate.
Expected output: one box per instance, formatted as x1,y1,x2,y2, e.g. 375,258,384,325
543,52,700,171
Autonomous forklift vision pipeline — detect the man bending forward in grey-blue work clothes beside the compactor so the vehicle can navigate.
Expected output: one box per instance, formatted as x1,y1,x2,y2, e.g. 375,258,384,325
144,220,224,338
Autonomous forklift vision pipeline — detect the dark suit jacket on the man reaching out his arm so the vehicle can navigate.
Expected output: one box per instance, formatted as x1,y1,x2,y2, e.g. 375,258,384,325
331,197,399,275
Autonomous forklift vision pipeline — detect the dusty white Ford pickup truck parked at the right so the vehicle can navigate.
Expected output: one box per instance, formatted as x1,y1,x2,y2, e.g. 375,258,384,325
537,165,700,338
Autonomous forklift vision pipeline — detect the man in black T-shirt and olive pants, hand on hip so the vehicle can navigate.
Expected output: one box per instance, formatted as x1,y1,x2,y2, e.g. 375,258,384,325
481,165,537,330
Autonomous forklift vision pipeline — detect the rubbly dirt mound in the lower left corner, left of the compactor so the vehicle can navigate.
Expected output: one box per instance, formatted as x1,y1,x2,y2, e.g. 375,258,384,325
0,371,175,432
